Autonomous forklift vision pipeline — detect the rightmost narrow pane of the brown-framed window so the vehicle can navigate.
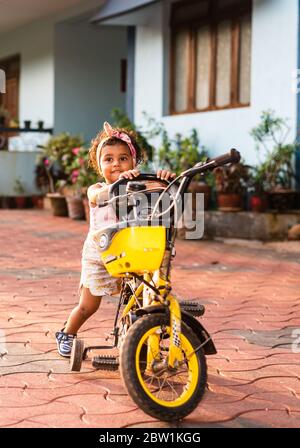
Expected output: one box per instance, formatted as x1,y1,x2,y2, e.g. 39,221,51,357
239,16,251,104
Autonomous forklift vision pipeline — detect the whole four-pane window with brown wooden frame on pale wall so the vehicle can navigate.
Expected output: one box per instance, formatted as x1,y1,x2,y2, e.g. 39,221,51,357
170,0,252,114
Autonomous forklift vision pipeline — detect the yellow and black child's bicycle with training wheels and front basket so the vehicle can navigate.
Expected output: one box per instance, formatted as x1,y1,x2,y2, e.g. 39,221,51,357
70,149,240,421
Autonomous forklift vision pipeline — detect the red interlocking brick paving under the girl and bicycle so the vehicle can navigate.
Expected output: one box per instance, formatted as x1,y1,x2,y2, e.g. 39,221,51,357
0,210,300,428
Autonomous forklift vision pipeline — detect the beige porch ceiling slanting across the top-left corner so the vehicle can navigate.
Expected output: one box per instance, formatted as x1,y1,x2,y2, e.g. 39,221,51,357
0,0,89,34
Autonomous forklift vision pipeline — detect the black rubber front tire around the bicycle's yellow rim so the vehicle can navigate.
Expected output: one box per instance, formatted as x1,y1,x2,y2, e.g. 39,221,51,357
120,314,207,421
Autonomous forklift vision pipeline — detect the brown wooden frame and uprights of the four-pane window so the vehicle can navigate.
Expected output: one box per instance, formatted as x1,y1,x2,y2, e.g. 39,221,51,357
169,0,252,115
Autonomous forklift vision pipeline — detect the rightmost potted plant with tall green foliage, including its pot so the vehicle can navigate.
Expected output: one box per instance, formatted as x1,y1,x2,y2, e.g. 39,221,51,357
250,110,299,211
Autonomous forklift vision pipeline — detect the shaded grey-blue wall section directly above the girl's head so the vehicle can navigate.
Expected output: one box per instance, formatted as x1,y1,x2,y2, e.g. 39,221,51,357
55,20,127,141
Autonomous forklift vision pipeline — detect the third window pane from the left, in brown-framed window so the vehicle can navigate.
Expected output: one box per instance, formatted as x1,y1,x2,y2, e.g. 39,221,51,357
216,21,231,107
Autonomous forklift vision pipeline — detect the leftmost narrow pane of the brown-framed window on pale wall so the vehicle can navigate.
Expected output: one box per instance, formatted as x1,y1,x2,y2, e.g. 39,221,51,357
174,31,189,112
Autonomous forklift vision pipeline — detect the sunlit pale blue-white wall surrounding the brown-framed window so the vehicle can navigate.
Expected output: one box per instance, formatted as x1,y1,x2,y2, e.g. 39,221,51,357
135,0,298,163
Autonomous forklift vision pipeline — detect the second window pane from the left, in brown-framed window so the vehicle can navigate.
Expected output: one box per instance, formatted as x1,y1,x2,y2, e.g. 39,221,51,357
196,26,211,109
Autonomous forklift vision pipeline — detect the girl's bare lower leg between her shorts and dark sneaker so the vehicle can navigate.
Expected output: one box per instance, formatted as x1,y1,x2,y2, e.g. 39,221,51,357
63,287,101,334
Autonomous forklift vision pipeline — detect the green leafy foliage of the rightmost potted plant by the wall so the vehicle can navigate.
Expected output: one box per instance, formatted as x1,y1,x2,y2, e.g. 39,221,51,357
250,110,299,191
